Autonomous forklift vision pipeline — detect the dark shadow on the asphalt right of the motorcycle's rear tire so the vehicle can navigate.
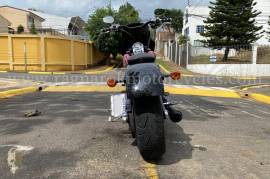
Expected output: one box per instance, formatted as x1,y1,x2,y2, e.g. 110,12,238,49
156,120,194,165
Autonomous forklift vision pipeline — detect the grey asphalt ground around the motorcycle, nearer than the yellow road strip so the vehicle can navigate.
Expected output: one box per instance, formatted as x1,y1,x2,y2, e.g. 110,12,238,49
0,92,270,179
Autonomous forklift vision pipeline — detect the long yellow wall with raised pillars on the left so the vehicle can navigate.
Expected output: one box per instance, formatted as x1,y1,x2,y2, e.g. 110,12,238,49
0,35,104,71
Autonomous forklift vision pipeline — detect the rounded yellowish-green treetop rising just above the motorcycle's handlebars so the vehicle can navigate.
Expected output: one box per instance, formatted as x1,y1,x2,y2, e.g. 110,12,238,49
116,2,140,25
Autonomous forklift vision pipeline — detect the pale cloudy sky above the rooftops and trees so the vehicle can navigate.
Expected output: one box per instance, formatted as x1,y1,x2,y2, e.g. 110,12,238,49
0,0,209,20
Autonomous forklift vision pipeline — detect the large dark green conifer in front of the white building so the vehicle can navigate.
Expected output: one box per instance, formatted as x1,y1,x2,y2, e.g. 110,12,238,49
202,0,262,61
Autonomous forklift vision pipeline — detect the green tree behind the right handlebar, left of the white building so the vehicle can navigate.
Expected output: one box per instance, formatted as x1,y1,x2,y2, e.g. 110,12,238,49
154,9,183,32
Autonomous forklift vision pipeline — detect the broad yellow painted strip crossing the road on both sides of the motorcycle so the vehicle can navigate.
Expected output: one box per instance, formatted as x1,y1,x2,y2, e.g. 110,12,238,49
43,85,241,98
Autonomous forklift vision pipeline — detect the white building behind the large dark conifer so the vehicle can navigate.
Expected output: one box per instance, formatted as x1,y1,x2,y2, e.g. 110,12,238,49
182,0,270,46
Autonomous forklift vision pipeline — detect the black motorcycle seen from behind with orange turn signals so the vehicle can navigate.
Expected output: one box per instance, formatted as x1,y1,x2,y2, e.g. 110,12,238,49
103,16,182,160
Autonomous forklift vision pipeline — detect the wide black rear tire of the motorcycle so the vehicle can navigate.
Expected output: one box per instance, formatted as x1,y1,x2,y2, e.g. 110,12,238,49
135,97,166,160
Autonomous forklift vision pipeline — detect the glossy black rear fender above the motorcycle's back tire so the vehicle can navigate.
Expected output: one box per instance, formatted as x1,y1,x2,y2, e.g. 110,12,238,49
125,63,164,97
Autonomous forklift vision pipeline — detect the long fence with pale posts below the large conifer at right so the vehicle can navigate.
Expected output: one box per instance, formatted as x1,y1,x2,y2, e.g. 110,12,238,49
164,41,270,67
